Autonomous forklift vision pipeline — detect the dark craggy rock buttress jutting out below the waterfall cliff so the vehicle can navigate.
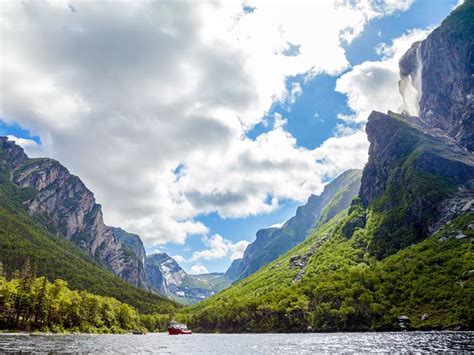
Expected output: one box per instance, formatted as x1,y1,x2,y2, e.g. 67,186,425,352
366,113,473,259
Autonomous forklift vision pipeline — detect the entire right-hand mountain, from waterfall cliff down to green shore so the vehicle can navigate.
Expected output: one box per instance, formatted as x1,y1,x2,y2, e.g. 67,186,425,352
182,0,474,332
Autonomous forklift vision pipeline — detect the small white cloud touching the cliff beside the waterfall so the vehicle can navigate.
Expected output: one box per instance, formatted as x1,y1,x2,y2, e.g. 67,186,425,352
336,28,432,123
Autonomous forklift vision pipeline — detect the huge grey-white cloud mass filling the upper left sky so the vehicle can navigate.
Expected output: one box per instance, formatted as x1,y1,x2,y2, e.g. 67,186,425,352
0,0,411,244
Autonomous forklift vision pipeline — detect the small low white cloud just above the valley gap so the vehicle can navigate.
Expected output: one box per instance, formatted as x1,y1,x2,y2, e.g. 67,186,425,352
190,234,249,261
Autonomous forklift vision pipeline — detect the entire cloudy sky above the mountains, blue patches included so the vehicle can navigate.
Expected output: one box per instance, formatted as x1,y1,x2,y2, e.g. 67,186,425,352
0,0,459,273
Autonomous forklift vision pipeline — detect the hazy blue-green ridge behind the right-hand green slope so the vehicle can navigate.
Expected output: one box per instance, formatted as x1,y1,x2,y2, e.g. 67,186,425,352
226,169,362,280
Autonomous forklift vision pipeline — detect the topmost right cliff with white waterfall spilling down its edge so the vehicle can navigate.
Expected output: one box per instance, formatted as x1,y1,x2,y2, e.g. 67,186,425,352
400,0,474,151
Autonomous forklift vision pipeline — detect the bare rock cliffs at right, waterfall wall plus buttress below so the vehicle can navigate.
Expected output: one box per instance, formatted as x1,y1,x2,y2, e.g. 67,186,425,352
360,0,474,258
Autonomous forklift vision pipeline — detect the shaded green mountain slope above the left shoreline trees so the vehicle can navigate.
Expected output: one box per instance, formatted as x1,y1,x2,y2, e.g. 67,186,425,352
0,167,176,313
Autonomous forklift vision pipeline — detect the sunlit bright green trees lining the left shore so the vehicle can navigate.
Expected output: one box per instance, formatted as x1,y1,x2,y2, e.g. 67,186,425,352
0,259,170,333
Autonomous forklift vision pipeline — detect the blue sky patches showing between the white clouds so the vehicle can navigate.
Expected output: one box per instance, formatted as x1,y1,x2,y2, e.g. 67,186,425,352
0,0,457,272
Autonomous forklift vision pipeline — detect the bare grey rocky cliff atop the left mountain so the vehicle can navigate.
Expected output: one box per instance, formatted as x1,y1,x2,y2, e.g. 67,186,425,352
0,137,146,288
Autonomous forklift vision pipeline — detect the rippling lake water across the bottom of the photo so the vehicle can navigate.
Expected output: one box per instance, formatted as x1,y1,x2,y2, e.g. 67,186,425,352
0,332,474,354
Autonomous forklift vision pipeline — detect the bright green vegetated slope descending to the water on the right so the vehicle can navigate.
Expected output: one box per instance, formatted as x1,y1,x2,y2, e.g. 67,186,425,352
178,208,474,332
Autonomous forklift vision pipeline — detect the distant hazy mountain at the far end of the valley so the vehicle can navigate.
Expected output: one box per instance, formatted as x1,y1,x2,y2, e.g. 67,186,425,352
146,253,231,304
